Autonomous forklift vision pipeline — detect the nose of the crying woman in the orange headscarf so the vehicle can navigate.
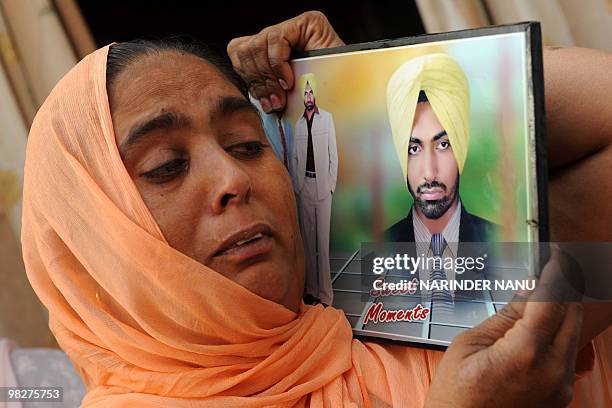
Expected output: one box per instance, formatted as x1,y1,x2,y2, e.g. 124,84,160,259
210,152,252,215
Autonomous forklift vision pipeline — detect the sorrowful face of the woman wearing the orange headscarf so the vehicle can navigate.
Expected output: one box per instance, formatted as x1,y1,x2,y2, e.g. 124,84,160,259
109,51,304,311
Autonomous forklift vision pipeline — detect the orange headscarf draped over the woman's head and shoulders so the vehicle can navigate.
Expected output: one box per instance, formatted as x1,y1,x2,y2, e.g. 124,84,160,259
22,47,608,408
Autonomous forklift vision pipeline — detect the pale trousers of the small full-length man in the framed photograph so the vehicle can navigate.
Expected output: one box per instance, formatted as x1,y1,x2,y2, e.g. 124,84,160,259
298,177,334,305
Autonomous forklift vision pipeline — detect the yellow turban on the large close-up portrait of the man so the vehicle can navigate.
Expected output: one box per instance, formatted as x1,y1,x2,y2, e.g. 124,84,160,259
387,54,470,183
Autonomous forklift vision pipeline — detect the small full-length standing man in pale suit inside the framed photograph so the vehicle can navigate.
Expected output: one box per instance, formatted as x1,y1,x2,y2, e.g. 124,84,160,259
292,73,338,305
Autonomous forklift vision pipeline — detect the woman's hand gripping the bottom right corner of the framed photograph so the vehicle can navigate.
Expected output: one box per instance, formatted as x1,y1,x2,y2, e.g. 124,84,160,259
425,245,582,408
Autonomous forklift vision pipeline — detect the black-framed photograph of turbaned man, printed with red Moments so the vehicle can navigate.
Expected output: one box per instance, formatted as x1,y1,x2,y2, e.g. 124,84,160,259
266,23,548,347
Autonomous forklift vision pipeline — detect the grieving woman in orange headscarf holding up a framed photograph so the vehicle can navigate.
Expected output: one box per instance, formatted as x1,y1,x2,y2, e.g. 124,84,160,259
22,22,608,407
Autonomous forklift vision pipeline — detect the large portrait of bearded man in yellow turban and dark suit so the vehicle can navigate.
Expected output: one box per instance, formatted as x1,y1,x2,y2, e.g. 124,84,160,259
387,53,494,243
